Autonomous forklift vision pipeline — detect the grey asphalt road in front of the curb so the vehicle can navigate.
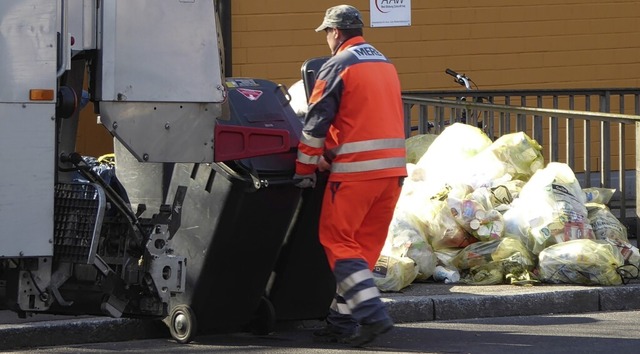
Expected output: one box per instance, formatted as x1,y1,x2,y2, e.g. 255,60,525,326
10,311,640,354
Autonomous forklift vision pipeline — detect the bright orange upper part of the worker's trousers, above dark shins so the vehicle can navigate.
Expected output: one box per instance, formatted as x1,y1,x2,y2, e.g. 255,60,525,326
319,177,404,270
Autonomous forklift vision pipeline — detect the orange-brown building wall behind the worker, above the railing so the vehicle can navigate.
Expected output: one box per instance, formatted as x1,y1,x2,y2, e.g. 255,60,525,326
78,0,640,156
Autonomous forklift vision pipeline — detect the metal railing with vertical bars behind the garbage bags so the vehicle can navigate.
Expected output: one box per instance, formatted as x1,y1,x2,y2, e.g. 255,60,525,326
403,88,640,227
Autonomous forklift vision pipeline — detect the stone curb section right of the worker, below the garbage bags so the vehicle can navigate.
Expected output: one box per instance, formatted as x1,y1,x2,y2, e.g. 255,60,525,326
383,283,640,323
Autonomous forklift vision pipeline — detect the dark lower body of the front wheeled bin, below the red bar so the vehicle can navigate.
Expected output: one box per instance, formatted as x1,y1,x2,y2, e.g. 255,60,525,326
172,164,300,331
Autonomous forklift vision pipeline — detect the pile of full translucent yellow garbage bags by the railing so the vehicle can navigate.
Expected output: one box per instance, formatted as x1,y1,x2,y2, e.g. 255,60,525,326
374,123,640,291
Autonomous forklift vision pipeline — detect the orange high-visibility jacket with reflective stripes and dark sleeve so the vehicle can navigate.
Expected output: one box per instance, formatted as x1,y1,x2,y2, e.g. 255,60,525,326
296,36,407,181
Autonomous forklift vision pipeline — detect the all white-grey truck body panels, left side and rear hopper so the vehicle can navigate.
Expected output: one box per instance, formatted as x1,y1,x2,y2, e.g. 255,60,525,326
0,0,225,257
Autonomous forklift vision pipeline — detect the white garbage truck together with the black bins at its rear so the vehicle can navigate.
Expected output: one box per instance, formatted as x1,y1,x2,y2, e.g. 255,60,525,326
0,0,335,343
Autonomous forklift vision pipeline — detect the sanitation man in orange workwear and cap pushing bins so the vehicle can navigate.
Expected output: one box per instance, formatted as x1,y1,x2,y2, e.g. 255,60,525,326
294,5,407,346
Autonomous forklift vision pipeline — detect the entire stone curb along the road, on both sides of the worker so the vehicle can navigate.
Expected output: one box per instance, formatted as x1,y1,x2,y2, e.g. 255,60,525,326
0,282,640,350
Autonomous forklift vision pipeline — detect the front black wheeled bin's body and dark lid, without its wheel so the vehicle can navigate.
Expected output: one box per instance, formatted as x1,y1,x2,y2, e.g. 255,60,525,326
168,78,302,331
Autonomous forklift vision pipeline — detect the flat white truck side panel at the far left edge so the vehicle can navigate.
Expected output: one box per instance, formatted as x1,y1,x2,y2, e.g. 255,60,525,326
0,0,59,257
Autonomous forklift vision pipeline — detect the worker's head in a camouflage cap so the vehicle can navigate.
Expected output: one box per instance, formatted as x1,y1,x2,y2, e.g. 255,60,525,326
316,5,364,53
